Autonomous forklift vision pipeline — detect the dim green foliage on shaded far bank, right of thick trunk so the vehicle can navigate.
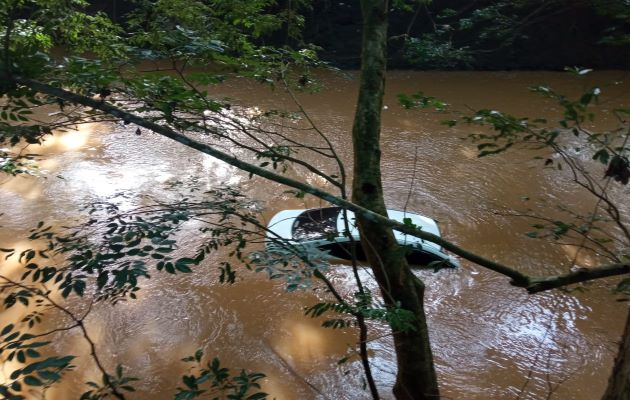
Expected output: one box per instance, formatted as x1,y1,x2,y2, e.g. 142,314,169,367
402,0,629,69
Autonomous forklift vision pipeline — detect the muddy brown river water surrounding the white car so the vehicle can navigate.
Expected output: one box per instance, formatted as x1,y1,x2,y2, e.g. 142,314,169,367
0,71,630,400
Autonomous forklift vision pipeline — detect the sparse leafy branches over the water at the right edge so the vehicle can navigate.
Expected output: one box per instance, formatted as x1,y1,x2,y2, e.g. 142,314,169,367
454,73,630,276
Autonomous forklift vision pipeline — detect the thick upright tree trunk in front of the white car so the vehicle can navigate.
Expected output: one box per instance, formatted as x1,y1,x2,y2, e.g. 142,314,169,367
352,0,439,400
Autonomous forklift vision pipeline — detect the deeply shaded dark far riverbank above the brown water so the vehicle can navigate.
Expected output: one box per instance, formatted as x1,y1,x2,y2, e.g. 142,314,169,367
91,0,630,70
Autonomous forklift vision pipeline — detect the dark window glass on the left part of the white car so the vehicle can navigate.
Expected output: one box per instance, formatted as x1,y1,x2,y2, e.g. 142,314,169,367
292,207,341,240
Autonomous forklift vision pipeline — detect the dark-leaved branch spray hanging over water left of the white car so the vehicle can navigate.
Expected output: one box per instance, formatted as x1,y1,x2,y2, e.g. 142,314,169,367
4,188,266,303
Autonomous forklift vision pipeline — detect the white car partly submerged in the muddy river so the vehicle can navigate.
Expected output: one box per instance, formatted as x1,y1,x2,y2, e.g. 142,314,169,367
266,207,459,267
